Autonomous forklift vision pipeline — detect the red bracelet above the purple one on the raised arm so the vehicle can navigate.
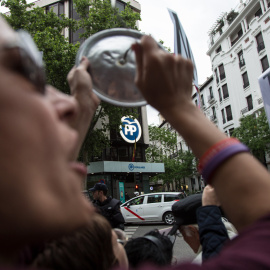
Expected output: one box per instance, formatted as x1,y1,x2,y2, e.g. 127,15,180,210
198,138,240,174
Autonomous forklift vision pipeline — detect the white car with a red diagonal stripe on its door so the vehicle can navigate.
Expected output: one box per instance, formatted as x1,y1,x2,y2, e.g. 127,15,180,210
121,192,185,225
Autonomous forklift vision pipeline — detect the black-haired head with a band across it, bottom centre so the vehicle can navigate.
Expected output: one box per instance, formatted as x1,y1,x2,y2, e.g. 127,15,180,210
125,230,173,268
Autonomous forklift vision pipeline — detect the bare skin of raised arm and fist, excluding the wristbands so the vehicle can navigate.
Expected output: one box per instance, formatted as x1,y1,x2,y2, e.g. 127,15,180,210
133,36,270,230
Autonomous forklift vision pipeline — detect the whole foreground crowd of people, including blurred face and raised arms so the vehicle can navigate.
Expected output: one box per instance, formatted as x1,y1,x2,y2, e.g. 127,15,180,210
0,14,270,270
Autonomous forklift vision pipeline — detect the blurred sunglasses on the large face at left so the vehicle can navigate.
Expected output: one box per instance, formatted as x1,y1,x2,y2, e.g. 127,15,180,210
4,30,46,94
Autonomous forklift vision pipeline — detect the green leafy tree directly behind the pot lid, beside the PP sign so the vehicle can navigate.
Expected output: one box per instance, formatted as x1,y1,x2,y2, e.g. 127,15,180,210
74,0,140,163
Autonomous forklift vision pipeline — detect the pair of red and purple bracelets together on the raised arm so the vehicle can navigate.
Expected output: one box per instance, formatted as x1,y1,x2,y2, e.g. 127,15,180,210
198,138,249,183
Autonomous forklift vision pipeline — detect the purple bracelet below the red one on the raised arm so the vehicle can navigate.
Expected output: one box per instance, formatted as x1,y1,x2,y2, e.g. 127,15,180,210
202,143,249,184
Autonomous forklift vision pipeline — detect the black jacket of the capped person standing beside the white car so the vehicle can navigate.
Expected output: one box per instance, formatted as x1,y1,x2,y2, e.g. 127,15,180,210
93,197,125,230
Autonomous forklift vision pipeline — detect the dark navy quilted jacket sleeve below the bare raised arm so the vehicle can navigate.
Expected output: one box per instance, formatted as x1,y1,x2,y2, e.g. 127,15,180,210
197,205,229,261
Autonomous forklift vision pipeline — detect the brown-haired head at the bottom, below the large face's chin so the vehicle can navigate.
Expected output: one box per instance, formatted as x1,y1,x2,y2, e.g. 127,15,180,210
33,214,128,270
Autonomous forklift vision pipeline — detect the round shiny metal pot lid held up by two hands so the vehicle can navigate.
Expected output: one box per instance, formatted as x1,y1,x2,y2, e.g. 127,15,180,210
76,28,147,107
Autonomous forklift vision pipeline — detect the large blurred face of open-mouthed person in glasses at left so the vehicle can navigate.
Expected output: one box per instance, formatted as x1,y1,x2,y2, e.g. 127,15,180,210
0,16,97,258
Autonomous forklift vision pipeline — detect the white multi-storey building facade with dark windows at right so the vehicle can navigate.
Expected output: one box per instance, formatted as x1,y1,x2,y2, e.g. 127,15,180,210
155,0,270,194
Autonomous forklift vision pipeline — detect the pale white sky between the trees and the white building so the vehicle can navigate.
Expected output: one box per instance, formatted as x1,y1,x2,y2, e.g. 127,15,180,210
137,0,240,125
